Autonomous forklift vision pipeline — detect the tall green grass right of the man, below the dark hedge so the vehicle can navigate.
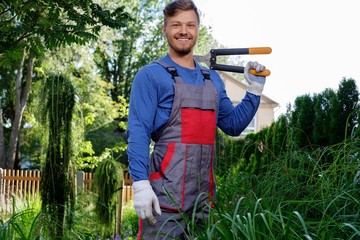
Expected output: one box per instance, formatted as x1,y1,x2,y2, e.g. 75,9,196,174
215,136,360,239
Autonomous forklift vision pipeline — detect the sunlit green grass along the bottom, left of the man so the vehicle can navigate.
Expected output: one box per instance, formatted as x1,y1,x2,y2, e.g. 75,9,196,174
0,192,138,240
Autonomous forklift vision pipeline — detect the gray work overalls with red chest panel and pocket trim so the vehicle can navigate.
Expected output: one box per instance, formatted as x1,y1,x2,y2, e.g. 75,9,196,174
139,62,218,239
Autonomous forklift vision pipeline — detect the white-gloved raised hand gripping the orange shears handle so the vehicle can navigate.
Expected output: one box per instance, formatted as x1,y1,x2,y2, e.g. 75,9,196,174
244,61,266,96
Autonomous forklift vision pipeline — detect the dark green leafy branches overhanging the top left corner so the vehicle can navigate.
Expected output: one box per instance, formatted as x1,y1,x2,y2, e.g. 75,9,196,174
0,0,130,59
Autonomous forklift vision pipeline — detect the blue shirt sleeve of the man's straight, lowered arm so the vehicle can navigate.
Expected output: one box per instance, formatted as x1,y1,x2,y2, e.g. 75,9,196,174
127,68,157,181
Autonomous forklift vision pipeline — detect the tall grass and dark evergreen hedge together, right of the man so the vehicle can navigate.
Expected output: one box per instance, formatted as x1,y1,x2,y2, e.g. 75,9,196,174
212,79,360,239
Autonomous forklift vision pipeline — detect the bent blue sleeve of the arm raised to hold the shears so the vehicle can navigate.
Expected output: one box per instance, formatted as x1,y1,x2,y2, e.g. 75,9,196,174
218,81,260,136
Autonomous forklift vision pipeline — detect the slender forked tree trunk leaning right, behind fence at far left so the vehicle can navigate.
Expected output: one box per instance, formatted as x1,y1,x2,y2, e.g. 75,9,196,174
6,48,34,169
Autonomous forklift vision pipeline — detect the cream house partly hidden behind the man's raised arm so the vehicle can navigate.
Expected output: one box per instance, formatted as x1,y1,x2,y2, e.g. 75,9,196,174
218,71,279,135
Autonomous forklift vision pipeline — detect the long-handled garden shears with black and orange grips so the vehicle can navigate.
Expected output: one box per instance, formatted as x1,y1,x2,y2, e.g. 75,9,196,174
194,47,272,77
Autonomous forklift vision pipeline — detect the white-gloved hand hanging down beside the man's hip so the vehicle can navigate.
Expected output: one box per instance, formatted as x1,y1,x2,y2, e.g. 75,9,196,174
132,180,161,225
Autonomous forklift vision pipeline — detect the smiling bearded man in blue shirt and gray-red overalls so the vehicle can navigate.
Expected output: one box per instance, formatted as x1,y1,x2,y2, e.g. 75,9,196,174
127,0,265,239
